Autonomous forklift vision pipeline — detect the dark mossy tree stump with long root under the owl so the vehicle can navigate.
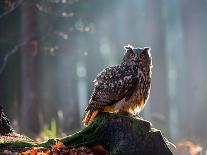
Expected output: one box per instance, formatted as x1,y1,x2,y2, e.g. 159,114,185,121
0,113,172,155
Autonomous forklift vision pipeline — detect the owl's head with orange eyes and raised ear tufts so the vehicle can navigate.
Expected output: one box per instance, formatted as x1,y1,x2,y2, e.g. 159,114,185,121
122,45,152,67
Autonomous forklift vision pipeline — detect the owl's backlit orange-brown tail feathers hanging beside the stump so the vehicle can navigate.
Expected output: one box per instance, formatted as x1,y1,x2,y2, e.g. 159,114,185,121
82,110,98,126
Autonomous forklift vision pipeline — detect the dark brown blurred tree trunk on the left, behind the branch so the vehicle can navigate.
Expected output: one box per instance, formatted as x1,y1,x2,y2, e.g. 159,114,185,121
20,1,41,134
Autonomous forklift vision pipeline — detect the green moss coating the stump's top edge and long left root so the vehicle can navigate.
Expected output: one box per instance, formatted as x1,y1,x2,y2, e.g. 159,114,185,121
0,113,150,149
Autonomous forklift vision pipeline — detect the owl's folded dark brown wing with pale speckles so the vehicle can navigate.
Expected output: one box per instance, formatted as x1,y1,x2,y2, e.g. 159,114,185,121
83,65,138,126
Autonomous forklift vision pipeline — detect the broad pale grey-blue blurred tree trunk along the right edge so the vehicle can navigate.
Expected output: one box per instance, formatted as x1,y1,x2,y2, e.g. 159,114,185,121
180,0,207,141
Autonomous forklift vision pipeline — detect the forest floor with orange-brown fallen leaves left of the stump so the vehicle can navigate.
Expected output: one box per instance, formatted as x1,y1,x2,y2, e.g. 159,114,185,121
0,133,110,155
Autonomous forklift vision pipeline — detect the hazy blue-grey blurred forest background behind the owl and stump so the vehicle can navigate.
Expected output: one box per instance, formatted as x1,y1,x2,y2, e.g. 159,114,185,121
0,0,207,151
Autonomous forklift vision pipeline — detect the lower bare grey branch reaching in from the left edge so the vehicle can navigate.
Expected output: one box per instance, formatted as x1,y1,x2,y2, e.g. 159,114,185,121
0,41,27,75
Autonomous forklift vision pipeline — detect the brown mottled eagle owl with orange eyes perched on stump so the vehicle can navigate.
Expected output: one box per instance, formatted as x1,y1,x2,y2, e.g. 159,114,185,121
82,45,152,126
